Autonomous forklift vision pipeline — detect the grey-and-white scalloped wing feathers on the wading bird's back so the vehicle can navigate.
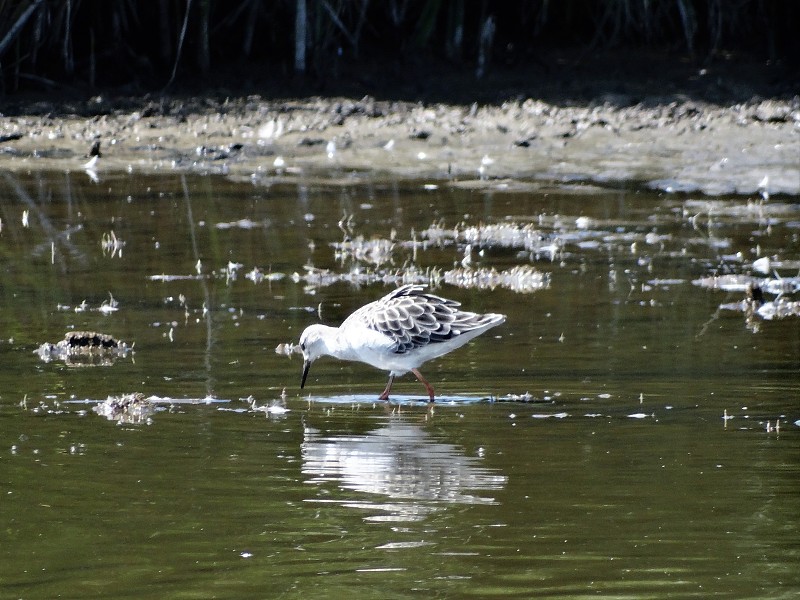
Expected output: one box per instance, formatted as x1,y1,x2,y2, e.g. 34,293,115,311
342,285,499,354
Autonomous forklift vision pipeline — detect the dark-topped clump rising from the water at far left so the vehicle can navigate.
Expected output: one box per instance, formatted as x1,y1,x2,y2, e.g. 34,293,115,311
35,331,133,367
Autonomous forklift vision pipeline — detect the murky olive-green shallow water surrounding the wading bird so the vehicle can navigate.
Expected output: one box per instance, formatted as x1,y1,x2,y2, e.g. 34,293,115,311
0,173,800,598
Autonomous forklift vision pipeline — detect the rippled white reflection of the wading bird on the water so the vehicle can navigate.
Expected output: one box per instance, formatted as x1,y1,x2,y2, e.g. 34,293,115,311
302,421,508,521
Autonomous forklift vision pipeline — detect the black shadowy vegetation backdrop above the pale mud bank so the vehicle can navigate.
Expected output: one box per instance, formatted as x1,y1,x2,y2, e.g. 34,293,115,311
0,0,800,115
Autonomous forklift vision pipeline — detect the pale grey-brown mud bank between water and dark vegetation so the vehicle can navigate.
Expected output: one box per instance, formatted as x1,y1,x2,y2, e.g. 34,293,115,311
0,95,800,195
